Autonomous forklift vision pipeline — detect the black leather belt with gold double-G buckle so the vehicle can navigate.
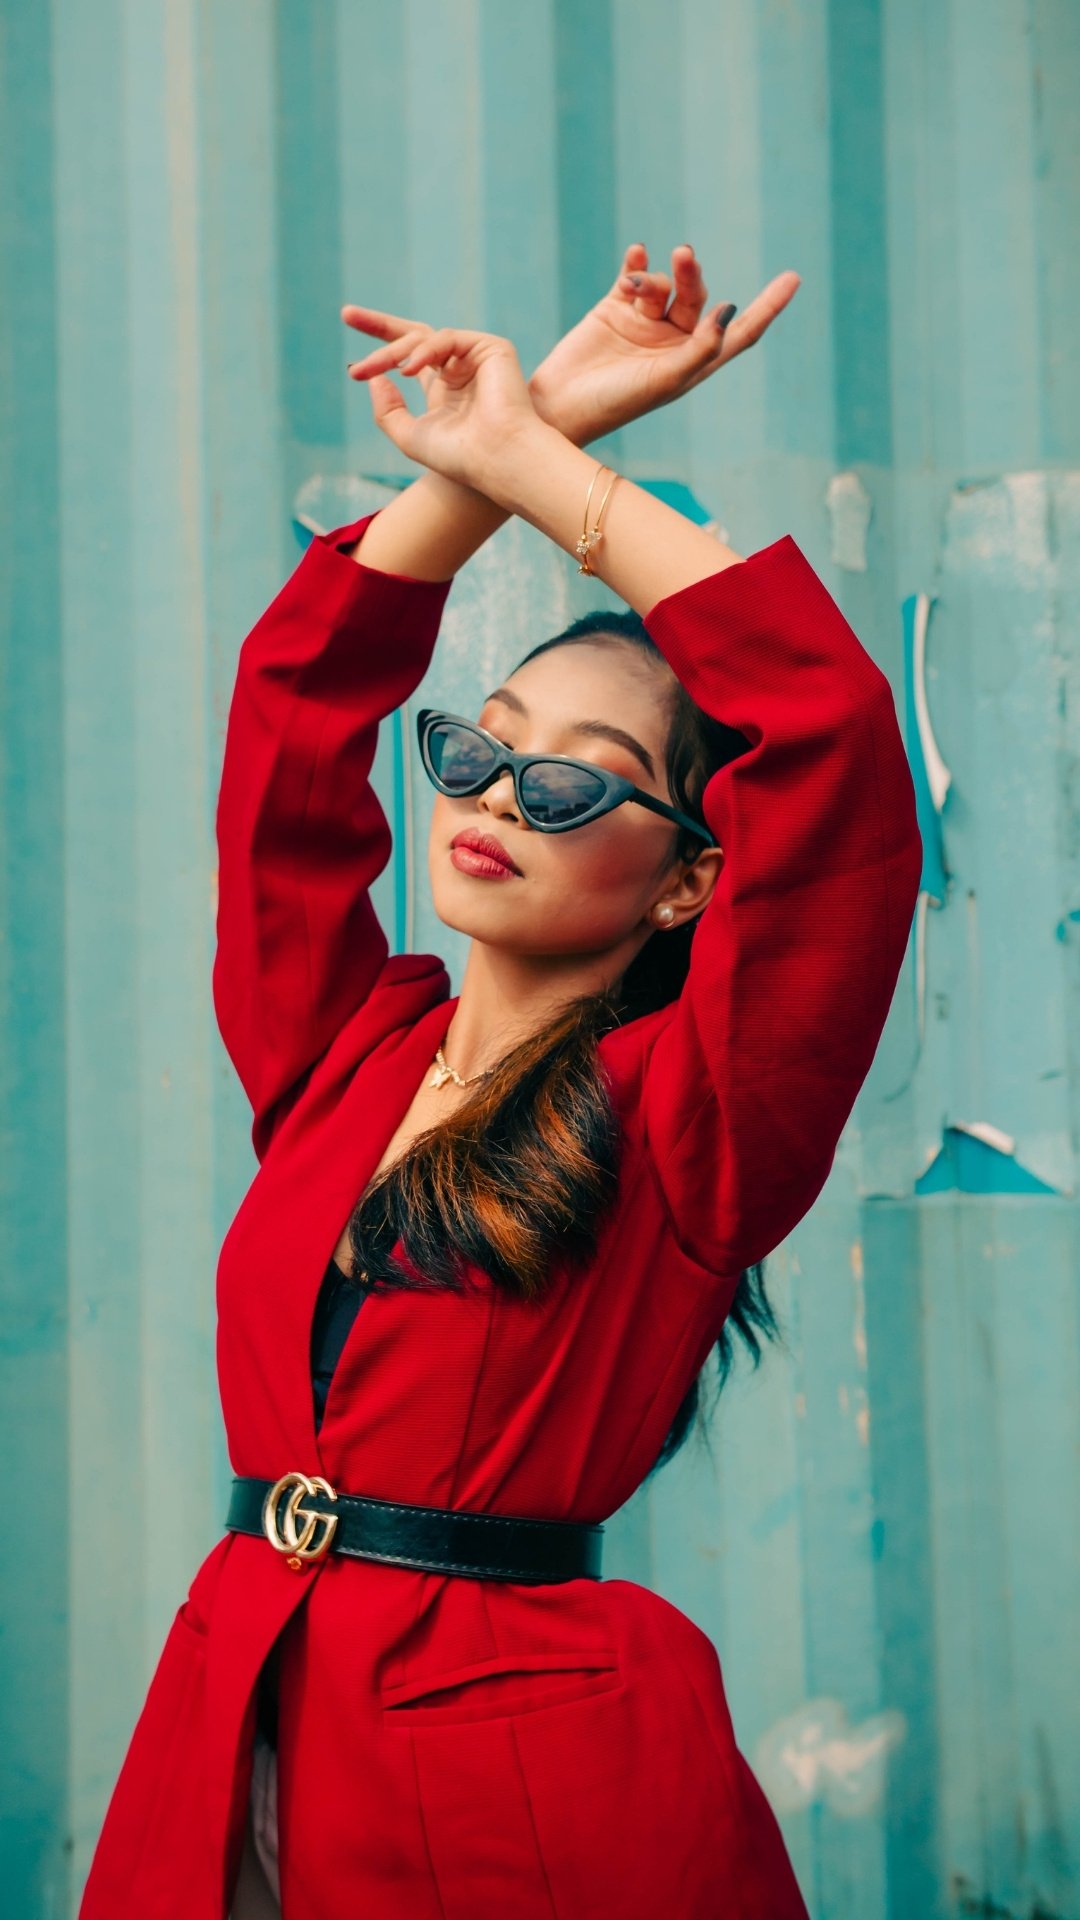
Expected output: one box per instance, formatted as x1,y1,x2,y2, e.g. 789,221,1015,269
225,1473,603,1582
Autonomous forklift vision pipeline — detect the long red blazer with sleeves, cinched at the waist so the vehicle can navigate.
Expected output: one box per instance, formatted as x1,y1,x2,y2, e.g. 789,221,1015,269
81,516,920,1920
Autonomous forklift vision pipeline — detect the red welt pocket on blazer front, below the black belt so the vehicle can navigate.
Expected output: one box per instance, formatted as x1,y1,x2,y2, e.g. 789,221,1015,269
380,1647,623,1726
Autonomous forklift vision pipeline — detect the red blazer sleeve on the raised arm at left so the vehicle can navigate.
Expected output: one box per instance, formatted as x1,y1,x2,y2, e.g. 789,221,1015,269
213,515,454,1158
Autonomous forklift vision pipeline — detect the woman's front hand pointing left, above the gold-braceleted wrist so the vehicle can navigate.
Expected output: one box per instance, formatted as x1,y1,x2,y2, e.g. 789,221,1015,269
343,326,540,493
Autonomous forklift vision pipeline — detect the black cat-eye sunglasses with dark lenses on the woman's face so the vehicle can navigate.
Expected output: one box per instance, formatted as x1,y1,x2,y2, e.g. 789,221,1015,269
417,707,719,847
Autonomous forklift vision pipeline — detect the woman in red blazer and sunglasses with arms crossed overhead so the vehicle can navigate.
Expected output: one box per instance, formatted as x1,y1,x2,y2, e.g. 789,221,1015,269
83,248,920,1920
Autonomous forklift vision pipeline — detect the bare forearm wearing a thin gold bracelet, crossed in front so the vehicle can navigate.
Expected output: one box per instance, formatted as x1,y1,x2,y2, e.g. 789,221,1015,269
482,420,742,614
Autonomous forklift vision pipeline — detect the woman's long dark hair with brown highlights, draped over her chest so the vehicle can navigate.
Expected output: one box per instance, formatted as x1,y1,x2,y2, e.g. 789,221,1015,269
350,609,780,1473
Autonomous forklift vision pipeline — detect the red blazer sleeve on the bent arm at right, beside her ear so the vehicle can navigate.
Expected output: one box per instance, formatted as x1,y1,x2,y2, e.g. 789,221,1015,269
644,534,922,1273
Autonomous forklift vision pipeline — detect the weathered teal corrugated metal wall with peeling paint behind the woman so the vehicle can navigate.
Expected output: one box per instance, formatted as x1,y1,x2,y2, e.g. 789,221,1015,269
0,0,1080,1920
